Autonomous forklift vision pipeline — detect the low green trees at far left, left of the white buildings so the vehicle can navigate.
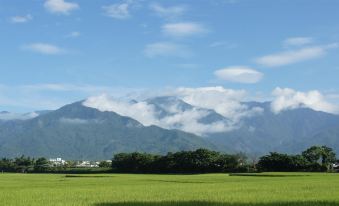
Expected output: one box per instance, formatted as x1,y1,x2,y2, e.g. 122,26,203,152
0,156,50,172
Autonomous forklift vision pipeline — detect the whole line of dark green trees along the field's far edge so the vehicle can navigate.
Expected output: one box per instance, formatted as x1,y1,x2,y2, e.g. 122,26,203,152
0,146,337,173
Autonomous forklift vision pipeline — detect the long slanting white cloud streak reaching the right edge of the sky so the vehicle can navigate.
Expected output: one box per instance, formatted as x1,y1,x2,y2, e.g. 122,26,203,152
255,43,338,67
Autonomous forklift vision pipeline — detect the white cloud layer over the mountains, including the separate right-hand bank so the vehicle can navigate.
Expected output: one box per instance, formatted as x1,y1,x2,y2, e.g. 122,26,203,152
83,87,338,135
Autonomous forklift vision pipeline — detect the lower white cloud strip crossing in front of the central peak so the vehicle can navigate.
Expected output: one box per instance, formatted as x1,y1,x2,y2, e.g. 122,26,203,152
83,92,246,135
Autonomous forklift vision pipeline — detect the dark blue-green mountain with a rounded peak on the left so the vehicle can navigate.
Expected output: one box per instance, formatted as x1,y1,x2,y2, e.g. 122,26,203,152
0,102,214,159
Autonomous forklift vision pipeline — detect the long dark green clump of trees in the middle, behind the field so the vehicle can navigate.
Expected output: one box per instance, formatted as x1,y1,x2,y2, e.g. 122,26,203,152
112,149,247,173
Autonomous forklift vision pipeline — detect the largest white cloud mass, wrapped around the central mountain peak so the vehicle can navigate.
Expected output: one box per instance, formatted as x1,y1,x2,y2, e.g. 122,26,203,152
83,87,263,135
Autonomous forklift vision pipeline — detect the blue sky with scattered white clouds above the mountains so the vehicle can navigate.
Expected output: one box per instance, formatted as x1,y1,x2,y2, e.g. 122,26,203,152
0,0,339,113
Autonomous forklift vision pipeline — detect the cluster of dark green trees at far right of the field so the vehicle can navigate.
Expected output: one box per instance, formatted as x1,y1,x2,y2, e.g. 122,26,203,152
257,146,336,172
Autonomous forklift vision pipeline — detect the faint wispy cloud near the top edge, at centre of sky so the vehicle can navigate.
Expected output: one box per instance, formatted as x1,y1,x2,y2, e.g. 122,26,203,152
150,4,186,19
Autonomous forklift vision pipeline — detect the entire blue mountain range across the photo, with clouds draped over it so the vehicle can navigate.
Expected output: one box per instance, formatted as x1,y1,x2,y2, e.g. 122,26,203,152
0,96,339,160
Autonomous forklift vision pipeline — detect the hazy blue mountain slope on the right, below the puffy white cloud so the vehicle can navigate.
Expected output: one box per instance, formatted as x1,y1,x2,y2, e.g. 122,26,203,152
209,102,339,155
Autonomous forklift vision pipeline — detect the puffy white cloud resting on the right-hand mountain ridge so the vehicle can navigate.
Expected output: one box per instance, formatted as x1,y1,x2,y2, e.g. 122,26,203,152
271,87,339,114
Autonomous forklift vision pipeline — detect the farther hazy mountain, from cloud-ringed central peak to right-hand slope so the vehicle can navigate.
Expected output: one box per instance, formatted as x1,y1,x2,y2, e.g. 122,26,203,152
138,97,339,155
